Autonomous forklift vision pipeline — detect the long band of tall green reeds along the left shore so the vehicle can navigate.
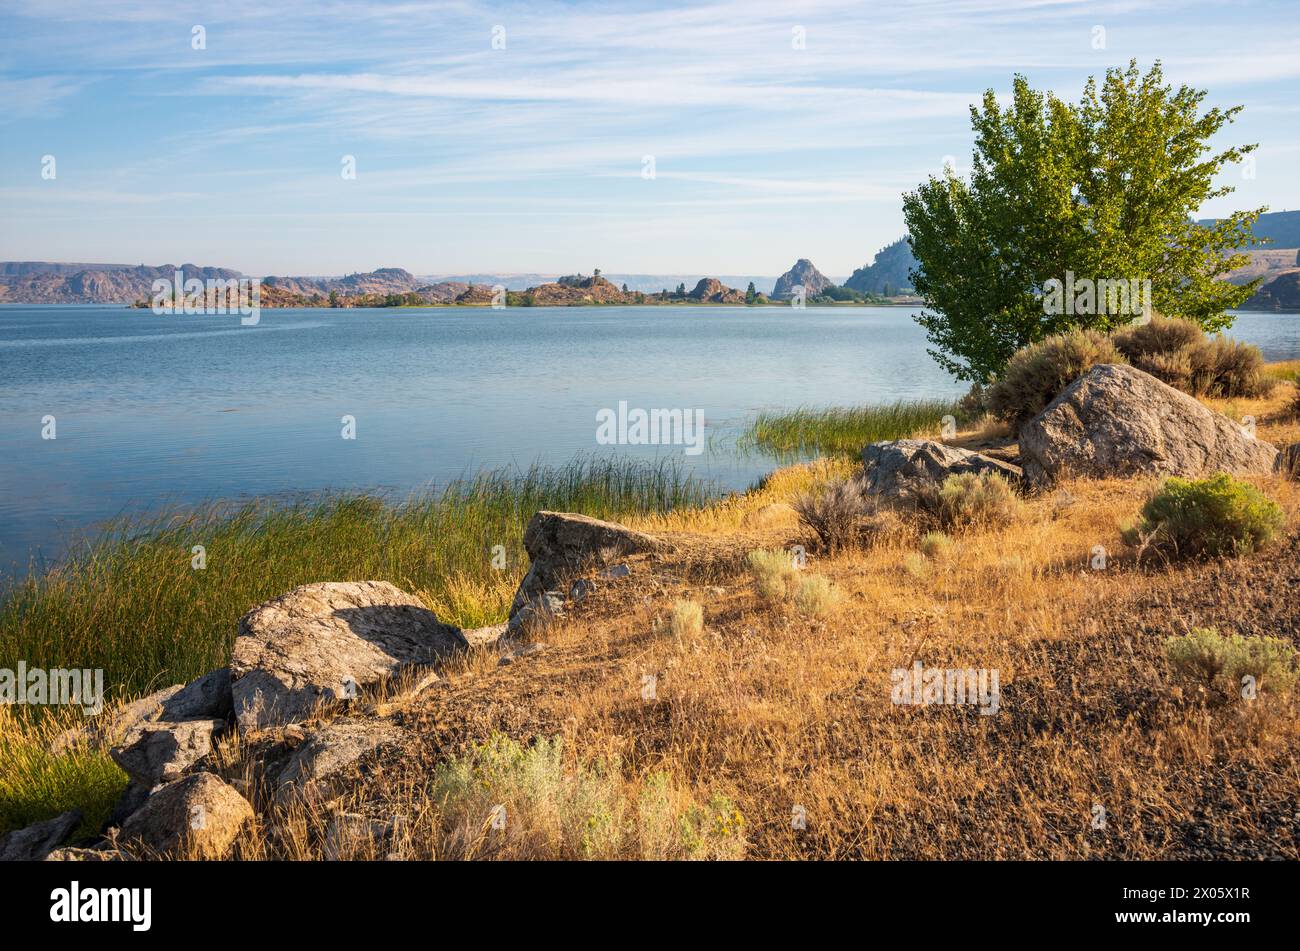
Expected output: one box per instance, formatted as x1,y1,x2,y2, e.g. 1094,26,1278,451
0,459,711,699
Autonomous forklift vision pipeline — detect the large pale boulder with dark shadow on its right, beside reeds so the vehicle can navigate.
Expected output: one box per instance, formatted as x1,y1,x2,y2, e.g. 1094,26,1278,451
230,581,468,730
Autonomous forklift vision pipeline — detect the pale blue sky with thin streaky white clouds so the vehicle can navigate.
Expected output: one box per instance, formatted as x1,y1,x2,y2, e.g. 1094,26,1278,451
0,0,1300,275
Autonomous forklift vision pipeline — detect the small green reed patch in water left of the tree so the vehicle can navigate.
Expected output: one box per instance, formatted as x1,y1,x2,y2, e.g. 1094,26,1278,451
738,400,959,456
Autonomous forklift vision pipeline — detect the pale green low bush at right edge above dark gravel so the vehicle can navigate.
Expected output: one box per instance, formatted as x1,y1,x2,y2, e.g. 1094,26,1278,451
1165,628,1297,695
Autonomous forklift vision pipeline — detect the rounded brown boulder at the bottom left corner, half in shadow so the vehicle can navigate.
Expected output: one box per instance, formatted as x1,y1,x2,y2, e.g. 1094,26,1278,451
118,773,254,859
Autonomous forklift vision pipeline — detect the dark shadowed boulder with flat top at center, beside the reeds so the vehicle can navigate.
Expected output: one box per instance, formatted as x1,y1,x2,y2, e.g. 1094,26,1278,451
508,512,664,630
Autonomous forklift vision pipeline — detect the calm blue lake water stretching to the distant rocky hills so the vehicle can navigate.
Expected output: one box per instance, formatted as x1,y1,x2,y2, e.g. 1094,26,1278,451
0,305,1300,572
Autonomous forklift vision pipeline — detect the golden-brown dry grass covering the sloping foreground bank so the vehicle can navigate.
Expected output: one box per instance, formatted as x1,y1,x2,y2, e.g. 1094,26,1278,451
22,368,1300,860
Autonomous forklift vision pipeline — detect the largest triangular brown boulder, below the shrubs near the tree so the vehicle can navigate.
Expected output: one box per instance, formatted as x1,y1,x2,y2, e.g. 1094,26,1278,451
1021,364,1278,487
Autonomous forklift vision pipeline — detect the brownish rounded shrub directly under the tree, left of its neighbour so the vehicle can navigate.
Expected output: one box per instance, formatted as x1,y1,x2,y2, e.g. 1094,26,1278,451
988,330,1127,427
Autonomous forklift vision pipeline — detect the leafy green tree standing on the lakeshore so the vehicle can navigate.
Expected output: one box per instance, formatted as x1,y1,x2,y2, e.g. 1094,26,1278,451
904,61,1265,382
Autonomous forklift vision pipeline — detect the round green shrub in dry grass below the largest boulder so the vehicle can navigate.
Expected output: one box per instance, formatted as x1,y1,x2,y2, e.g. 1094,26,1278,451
1125,473,1284,557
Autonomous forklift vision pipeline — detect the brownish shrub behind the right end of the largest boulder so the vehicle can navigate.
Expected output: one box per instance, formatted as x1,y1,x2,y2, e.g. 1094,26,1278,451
1112,314,1274,396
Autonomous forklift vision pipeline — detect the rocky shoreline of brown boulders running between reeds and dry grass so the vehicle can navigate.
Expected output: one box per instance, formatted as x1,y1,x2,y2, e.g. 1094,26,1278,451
0,365,1300,860
